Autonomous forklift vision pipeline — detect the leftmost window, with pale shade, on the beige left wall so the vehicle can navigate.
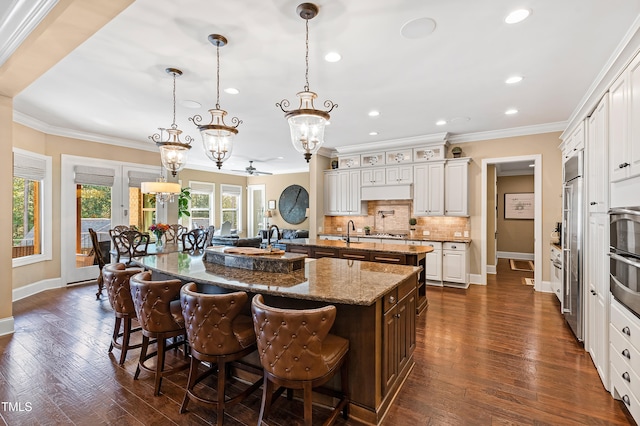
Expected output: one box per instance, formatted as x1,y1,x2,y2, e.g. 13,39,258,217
11,148,52,266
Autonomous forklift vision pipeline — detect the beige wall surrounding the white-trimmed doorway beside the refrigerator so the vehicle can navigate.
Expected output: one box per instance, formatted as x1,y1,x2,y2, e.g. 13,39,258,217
454,132,562,281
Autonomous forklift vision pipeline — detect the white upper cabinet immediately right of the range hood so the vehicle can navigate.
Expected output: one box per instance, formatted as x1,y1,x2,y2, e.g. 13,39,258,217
413,161,444,216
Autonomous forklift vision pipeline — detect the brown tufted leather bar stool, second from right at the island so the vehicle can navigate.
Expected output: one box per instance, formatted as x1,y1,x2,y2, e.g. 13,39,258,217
180,283,262,425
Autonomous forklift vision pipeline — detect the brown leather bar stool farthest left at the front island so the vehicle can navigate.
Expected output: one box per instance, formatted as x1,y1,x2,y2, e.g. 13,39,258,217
102,263,143,365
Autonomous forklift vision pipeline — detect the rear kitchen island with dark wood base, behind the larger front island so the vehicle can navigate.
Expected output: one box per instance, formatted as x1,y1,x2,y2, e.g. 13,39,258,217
281,238,433,314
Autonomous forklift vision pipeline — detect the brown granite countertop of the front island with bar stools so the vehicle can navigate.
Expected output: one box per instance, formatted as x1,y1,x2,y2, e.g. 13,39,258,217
134,251,426,306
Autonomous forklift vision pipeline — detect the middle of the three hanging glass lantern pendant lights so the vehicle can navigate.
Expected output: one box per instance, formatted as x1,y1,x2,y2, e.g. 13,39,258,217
189,34,242,169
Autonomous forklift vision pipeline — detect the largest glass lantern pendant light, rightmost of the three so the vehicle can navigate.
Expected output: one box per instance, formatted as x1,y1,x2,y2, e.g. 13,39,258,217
276,3,338,163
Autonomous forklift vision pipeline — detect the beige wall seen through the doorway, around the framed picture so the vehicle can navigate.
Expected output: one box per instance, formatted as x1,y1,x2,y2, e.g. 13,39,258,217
498,175,535,254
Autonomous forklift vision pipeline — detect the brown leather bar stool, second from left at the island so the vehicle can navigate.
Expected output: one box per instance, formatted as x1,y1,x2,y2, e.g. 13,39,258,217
129,271,189,396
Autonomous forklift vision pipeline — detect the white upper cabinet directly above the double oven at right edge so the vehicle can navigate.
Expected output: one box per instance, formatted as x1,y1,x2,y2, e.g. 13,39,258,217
609,52,640,182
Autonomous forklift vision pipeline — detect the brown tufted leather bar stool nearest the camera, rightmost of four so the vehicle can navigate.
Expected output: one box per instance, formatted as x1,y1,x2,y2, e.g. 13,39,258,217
251,294,349,425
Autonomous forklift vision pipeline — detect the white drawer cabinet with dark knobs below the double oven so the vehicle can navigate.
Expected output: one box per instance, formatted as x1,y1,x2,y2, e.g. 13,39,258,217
609,299,640,422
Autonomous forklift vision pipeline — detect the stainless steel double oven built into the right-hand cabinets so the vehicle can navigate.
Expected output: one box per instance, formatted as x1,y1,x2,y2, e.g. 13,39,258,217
609,207,640,316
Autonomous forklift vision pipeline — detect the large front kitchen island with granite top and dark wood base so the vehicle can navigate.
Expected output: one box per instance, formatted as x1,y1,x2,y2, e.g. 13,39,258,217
134,249,421,424
